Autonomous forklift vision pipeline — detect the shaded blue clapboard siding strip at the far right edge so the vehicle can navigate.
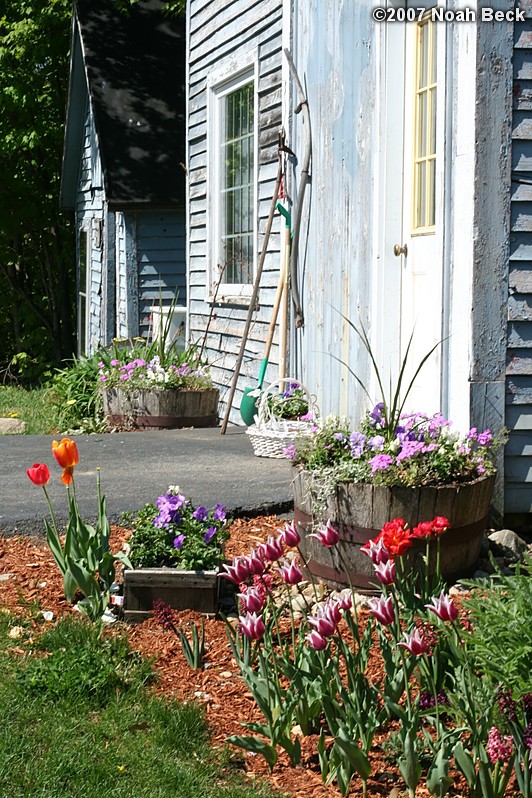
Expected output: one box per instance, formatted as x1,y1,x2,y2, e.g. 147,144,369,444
504,11,532,514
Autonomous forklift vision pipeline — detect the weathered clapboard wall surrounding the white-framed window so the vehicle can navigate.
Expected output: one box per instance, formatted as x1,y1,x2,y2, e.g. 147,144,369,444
187,0,283,423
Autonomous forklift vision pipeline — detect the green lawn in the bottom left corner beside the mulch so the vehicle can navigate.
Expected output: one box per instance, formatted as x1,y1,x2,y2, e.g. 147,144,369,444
0,613,282,798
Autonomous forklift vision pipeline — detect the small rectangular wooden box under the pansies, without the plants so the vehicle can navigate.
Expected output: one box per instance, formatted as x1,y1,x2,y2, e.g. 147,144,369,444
124,568,219,623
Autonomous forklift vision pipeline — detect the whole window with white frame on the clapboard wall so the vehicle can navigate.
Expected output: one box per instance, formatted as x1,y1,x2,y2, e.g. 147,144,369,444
208,54,257,301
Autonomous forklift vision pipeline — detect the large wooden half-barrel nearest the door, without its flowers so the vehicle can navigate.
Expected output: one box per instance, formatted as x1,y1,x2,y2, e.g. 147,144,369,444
293,468,495,592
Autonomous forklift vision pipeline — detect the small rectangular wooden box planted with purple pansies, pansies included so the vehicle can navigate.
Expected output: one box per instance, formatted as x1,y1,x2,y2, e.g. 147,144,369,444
124,486,229,621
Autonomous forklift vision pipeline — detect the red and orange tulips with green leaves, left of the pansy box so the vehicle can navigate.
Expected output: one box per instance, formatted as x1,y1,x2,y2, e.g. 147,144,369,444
26,438,131,621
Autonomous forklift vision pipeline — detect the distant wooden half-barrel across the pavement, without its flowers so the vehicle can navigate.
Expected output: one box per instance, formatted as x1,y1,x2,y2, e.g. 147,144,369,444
103,387,219,429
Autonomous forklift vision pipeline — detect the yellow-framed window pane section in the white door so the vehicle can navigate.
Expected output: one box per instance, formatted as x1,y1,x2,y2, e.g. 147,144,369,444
413,18,436,233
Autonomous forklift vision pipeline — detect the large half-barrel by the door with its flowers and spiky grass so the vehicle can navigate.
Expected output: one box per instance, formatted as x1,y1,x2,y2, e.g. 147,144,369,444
285,328,504,590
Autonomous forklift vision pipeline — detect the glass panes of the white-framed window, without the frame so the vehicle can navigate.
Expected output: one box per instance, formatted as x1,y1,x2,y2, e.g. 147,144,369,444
218,81,255,285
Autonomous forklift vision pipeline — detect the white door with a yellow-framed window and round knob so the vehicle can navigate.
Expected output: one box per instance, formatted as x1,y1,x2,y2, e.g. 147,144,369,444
376,3,445,412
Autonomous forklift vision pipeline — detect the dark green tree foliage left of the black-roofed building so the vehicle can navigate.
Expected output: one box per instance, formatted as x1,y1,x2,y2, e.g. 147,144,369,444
0,0,75,382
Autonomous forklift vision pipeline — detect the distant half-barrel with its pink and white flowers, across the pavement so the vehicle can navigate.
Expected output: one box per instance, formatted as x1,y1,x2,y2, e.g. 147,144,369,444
98,338,219,429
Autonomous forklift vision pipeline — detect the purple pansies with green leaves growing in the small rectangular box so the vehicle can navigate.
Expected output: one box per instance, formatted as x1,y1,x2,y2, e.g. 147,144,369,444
125,485,229,571
